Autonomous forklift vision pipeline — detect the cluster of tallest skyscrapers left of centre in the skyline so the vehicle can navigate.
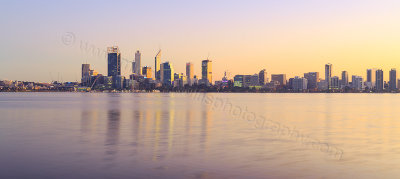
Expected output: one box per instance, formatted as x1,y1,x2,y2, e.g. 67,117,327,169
80,46,213,91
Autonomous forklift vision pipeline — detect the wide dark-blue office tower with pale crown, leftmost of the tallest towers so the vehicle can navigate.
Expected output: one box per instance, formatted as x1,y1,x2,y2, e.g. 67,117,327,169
107,46,121,76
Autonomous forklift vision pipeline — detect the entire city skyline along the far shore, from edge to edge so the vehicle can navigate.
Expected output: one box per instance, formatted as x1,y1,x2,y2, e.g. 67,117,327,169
0,46,400,92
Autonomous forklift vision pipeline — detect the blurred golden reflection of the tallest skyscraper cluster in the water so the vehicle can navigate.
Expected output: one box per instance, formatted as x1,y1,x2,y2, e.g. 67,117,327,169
77,94,216,163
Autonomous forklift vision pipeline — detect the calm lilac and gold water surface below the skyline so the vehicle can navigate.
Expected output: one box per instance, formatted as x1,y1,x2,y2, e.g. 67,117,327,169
0,93,400,178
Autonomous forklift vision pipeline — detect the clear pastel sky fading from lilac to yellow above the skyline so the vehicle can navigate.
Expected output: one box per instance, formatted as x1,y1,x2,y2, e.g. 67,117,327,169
0,0,400,82
